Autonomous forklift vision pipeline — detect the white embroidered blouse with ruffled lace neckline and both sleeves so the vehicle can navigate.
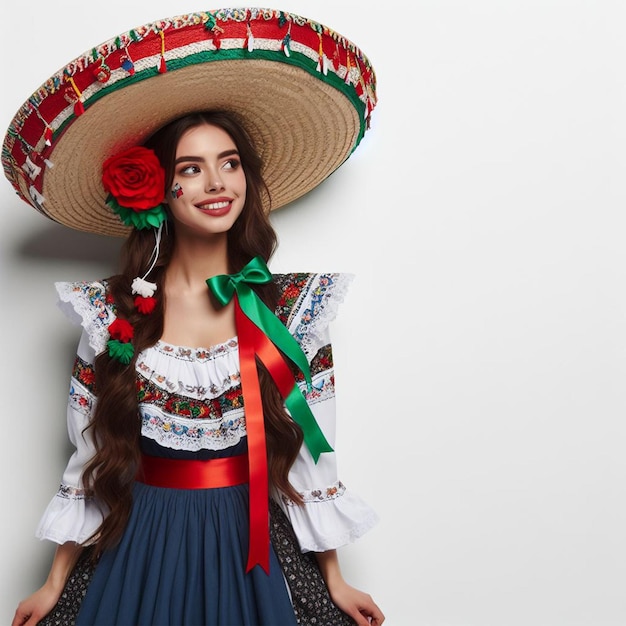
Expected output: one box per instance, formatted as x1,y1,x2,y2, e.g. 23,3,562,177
37,274,378,552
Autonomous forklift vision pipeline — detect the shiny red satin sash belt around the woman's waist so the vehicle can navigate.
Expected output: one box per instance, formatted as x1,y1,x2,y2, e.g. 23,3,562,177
137,454,248,489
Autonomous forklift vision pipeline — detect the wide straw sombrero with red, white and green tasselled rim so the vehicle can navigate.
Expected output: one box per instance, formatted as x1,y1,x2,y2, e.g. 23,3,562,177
2,8,376,235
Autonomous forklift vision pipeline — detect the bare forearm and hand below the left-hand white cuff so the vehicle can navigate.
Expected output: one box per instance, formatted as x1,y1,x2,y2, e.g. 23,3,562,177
11,541,83,626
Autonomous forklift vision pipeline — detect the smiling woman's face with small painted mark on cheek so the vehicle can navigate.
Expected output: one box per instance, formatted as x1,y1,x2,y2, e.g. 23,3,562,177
167,124,246,235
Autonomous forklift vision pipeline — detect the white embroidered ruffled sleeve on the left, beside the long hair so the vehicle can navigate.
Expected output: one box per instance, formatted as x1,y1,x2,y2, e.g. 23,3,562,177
36,283,114,544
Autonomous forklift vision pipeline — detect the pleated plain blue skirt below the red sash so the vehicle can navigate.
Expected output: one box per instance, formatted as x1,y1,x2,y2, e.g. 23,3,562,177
76,483,297,626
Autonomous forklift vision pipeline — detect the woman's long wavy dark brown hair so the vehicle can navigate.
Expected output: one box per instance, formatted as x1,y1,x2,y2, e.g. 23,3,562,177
83,111,303,554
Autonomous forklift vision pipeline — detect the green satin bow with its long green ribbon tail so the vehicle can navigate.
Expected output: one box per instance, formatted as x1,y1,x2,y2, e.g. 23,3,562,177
206,256,333,463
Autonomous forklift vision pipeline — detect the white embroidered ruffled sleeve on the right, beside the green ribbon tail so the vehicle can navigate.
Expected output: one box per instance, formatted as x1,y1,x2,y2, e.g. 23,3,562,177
274,274,378,552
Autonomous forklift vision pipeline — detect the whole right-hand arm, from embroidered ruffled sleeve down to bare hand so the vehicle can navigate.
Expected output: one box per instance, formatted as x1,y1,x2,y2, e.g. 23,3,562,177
277,274,385,626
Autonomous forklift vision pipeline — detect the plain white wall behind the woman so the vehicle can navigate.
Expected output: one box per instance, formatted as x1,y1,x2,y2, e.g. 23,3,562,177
0,0,626,626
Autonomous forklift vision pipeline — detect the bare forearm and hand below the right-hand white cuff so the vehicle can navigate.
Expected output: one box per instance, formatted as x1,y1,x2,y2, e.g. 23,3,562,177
315,550,385,626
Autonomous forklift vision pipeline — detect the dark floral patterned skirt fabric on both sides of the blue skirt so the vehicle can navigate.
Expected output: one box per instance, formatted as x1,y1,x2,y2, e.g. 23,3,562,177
38,501,354,626
